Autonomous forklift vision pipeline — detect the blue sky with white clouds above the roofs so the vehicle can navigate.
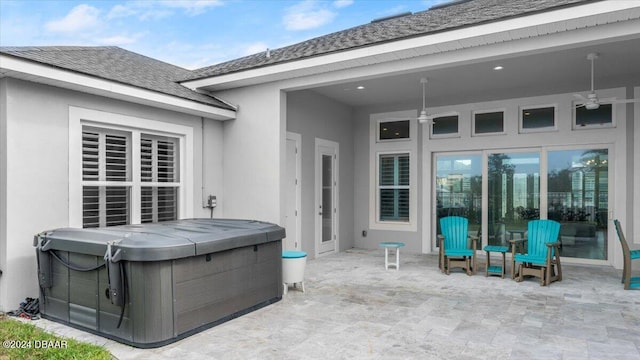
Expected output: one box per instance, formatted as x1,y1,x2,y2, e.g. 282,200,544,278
0,0,447,69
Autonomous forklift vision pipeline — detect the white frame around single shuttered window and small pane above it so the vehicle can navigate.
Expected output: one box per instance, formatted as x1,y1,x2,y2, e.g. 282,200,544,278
369,110,418,232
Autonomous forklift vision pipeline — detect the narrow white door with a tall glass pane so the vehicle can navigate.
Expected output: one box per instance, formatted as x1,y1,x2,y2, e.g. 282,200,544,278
315,139,338,256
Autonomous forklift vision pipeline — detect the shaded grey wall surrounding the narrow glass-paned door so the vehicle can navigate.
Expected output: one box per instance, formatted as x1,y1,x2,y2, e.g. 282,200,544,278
287,91,356,255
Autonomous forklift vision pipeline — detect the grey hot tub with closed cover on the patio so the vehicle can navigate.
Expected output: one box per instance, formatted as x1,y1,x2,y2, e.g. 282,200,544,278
34,219,285,348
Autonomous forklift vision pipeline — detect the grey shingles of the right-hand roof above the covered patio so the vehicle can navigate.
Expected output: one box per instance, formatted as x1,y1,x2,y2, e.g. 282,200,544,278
183,0,601,81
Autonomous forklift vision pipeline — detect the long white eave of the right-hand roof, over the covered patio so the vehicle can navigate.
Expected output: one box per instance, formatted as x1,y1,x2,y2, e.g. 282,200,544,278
181,1,640,91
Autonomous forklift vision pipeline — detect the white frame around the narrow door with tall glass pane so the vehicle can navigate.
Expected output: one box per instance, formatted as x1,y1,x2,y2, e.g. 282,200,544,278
313,138,340,257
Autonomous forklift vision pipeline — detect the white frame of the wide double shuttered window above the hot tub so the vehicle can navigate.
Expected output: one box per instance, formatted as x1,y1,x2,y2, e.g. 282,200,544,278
69,106,194,228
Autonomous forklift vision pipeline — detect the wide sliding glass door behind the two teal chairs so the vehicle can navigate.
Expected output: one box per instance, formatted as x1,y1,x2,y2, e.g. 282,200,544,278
433,147,609,260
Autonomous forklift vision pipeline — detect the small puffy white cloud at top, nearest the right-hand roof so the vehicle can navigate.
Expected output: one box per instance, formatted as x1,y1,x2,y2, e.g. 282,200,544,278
282,0,336,30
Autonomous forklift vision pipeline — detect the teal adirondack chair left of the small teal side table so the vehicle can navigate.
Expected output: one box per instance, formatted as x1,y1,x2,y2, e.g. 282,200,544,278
440,216,478,275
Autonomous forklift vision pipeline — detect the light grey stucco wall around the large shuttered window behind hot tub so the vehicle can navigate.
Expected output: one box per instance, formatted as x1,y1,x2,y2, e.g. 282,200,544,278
0,78,224,311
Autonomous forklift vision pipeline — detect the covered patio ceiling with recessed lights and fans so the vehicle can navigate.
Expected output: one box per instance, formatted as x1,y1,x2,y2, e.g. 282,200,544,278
312,38,640,107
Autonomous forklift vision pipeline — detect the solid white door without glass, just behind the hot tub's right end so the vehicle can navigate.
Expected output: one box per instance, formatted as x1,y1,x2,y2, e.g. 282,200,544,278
282,133,301,250
